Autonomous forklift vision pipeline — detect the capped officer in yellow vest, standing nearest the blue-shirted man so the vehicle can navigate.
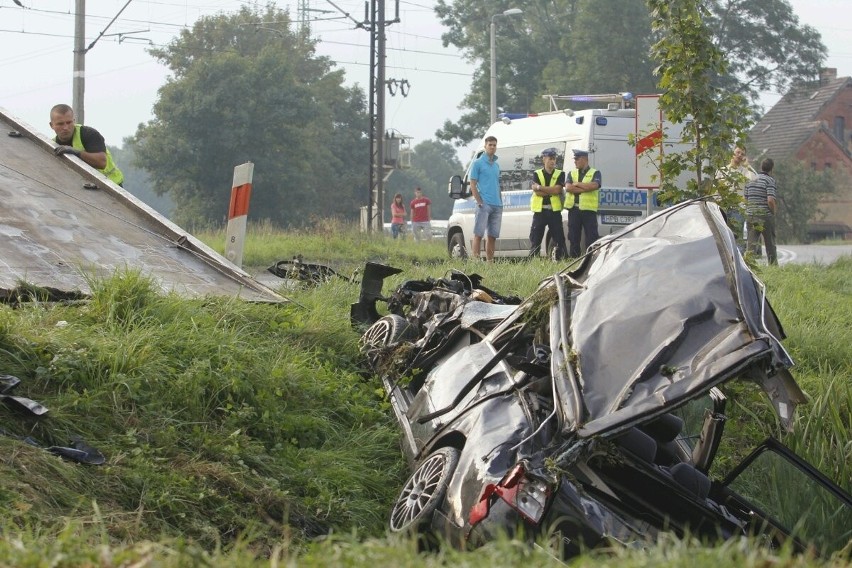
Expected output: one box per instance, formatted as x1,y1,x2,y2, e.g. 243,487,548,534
530,148,568,260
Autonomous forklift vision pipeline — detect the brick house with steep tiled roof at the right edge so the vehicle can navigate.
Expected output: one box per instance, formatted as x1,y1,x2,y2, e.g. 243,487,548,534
749,69,852,242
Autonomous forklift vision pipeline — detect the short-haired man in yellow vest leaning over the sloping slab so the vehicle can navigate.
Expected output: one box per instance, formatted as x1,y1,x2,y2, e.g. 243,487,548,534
50,104,124,185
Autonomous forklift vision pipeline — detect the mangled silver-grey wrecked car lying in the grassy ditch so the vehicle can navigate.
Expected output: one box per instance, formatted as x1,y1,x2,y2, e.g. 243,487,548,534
351,200,852,556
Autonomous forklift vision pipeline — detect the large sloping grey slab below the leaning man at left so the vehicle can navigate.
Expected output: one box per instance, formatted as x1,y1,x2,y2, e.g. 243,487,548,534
0,109,286,302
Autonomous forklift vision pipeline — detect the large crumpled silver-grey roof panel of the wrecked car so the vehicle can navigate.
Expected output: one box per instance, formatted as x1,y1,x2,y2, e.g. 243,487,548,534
545,200,805,437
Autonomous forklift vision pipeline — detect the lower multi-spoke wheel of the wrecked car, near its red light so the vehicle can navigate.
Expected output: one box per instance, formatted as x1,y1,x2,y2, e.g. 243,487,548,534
390,448,459,532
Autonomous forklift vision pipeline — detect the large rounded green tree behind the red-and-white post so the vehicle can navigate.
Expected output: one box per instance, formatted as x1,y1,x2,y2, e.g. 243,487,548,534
132,6,368,227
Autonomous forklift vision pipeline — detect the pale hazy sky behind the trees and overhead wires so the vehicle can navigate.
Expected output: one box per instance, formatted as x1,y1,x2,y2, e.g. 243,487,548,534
0,0,852,161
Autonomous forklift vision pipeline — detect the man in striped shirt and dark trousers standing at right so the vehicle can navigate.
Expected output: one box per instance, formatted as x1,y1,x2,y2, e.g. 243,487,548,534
744,158,778,264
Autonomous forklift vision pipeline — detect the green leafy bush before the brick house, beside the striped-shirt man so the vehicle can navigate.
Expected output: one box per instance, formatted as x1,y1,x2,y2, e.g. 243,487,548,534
772,159,837,243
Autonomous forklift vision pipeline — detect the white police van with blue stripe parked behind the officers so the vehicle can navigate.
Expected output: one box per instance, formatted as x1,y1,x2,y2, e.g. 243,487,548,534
446,96,684,258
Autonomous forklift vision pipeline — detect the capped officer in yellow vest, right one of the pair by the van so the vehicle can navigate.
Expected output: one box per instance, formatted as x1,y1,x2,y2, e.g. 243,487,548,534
565,150,601,258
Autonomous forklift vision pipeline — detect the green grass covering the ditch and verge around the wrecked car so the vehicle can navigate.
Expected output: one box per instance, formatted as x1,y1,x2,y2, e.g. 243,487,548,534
0,223,852,568
